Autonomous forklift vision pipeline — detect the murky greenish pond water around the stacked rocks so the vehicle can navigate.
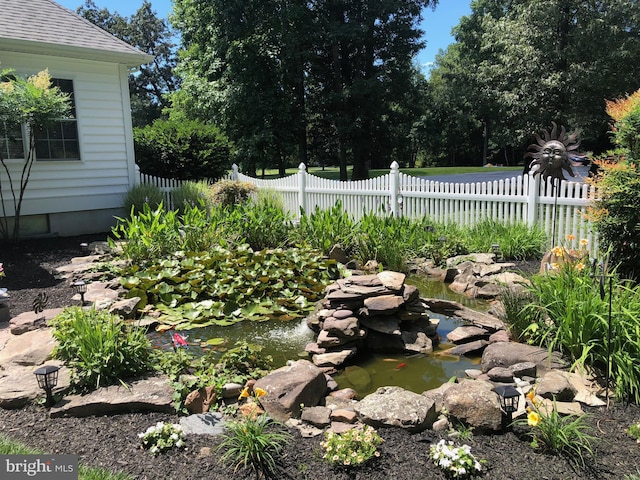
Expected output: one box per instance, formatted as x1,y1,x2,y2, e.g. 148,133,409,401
151,276,488,396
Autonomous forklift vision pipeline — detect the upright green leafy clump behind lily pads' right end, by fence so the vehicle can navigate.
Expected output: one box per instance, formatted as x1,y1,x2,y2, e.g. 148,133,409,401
291,201,355,254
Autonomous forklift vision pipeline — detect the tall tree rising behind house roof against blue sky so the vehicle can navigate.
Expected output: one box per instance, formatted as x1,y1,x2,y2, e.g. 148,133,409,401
77,0,180,126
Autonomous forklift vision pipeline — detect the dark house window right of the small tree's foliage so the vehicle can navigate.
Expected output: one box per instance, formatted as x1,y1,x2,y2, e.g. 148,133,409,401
36,78,80,161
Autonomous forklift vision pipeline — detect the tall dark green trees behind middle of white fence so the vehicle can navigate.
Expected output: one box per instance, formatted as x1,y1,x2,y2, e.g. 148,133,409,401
172,0,436,179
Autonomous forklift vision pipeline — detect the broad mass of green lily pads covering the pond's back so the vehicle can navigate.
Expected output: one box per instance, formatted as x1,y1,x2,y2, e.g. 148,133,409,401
121,245,338,329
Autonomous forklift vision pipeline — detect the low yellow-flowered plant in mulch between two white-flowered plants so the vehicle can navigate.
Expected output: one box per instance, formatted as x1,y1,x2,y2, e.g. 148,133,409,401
320,425,383,467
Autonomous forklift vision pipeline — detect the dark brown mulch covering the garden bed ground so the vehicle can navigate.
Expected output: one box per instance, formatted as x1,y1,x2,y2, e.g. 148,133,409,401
0,235,640,480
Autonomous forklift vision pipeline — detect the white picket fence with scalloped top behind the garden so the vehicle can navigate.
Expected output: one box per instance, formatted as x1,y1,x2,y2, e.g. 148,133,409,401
136,162,597,248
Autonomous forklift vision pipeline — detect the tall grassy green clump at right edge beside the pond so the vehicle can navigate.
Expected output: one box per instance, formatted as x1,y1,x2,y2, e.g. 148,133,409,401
521,256,640,401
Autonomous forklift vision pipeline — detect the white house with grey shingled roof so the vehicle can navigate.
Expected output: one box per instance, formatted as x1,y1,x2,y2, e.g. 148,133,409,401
0,0,153,236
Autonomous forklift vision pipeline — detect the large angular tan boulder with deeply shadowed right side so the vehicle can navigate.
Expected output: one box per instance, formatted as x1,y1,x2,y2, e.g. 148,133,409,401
254,360,327,422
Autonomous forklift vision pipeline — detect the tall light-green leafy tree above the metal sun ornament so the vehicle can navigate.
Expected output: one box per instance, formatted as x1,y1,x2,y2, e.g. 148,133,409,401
428,0,640,161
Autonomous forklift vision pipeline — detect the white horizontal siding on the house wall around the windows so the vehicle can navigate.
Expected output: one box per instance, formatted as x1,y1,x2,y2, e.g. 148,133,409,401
0,51,135,215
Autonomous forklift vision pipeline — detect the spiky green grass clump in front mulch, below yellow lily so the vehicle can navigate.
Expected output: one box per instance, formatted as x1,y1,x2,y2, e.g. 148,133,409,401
218,414,291,478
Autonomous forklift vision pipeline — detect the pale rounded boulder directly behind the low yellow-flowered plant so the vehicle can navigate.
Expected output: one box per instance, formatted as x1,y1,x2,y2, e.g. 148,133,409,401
354,387,438,432
